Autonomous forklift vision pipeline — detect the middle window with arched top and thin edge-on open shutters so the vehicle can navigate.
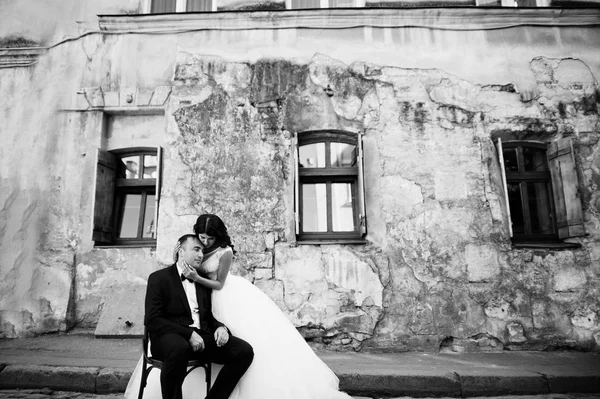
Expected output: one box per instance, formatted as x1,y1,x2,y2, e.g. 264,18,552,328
293,130,366,243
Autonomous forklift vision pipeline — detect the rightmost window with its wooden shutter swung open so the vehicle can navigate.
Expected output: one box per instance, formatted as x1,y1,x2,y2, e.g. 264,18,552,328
497,139,584,247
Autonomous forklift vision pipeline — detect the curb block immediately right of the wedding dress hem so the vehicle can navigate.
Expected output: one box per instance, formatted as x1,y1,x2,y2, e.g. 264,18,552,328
338,373,461,397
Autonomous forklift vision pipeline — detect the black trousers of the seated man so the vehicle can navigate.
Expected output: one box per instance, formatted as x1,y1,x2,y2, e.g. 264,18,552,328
152,331,254,399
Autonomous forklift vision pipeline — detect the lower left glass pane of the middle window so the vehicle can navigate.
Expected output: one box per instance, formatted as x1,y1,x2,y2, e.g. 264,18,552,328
302,183,327,232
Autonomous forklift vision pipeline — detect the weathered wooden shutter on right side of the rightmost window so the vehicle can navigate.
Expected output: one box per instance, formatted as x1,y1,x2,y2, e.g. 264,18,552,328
547,138,585,238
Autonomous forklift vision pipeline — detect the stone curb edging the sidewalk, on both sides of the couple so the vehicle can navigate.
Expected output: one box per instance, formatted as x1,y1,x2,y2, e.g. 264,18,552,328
0,364,600,398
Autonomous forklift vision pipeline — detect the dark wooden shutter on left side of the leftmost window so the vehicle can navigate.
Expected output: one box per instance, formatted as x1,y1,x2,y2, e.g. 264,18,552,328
92,149,117,243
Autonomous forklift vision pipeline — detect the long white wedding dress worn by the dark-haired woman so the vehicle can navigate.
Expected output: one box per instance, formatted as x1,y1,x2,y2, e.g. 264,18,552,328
125,247,350,399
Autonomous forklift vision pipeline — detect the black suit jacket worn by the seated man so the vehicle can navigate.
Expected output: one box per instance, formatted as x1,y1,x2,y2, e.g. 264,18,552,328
144,264,223,340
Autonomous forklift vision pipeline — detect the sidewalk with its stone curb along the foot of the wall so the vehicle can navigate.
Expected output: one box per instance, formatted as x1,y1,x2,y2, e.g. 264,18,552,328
0,334,600,399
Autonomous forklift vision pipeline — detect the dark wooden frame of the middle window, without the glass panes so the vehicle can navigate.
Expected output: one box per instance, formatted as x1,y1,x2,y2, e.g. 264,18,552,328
294,130,366,244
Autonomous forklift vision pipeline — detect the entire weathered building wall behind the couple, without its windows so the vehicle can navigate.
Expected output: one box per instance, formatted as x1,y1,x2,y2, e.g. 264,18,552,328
0,3,600,351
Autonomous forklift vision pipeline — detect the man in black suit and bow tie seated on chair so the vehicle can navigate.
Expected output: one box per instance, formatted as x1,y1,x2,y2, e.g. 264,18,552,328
144,234,254,399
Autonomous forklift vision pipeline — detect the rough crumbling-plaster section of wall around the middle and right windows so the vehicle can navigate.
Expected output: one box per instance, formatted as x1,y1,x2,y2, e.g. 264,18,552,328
154,49,600,350
